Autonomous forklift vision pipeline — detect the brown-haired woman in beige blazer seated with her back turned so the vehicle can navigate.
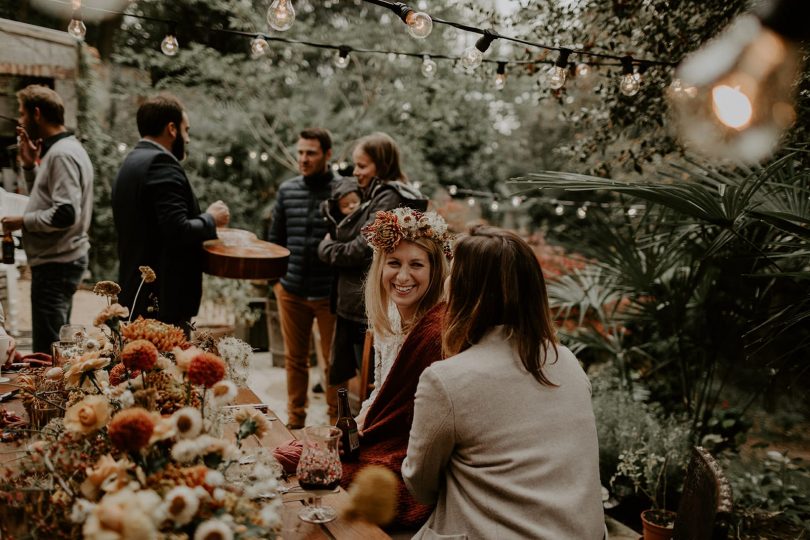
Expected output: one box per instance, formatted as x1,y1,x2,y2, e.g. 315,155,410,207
402,227,605,540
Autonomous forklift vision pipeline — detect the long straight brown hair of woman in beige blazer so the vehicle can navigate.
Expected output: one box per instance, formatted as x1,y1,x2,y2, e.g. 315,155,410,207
442,226,559,386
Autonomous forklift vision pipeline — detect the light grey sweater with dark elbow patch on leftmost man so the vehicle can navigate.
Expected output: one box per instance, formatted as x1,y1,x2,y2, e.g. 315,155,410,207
23,134,93,266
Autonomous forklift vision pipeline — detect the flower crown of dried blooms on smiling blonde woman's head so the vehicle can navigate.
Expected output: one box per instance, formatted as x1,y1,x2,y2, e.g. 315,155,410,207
361,208,453,259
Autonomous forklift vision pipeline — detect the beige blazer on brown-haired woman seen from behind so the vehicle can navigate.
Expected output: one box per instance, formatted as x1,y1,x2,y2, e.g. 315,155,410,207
402,328,605,540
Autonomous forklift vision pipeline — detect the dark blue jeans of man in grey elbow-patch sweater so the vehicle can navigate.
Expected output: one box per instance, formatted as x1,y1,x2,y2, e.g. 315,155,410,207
31,255,87,354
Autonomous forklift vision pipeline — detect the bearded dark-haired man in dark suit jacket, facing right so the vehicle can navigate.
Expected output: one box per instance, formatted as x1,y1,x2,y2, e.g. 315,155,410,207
112,94,230,334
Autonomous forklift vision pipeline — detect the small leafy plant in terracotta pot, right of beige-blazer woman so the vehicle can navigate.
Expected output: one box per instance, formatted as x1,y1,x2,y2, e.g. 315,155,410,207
610,447,675,540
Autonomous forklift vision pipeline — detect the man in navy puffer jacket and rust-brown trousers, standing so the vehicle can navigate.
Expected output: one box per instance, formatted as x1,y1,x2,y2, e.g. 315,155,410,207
268,128,338,429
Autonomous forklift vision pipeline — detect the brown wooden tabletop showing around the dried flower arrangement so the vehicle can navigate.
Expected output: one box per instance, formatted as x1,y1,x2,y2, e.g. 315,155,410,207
0,374,390,540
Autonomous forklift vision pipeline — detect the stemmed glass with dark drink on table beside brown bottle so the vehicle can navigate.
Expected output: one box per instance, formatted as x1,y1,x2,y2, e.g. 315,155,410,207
296,426,343,523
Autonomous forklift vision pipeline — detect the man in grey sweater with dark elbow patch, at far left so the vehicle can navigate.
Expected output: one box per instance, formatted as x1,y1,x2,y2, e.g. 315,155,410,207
3,85,93,353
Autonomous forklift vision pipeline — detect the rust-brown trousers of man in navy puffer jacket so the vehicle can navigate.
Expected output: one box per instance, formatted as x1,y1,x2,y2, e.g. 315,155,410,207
273,283,338,425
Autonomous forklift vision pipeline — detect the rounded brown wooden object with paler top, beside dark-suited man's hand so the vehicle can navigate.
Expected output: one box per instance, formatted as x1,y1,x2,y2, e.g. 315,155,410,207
203,228,290,279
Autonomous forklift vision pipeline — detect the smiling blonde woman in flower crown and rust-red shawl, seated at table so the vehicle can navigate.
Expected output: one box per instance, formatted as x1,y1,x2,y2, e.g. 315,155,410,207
342,208,451,528
